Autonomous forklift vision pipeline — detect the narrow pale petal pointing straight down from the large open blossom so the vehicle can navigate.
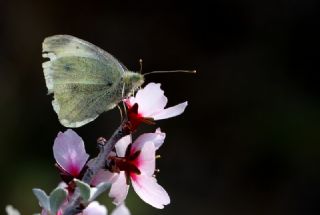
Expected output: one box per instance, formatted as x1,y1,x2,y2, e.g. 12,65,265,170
109,171,129,205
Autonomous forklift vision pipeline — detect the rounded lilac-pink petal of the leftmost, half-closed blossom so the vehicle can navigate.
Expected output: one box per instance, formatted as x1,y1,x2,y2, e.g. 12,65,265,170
53,129,89,176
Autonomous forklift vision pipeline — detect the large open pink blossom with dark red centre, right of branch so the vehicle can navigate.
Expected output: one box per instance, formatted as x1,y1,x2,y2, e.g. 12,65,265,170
94,129,170,209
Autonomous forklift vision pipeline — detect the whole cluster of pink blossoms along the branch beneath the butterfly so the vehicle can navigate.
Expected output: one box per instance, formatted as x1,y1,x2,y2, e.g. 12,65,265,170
34,83,187,215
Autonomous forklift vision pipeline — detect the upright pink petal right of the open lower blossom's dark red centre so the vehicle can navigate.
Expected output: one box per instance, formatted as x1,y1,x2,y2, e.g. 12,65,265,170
135,139,156,177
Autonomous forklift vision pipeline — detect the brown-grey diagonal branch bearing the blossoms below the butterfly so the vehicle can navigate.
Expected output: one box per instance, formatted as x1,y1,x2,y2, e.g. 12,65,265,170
63,120,130,215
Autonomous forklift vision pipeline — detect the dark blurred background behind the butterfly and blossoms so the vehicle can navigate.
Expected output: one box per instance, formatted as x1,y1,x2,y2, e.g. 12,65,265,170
0,0,320,215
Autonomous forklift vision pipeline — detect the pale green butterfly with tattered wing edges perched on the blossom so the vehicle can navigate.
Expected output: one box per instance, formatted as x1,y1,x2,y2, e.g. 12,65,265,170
42,35,144,127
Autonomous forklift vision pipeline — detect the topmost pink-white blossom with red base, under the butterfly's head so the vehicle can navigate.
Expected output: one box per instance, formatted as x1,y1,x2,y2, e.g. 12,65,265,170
124,83,188,129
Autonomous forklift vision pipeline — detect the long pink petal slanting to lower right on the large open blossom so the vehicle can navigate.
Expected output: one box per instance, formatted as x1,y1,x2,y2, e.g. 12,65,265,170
132,175,170,209
